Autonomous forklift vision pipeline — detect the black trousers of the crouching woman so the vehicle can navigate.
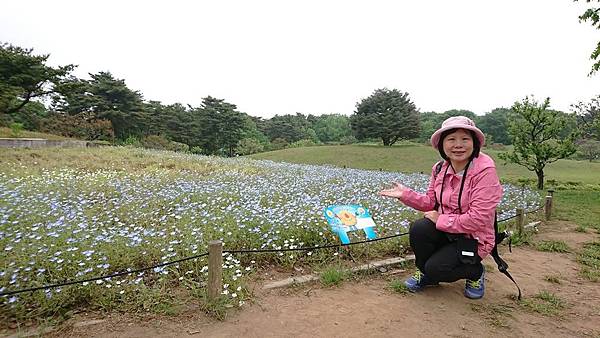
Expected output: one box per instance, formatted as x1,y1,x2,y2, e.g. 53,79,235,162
409,218,483,283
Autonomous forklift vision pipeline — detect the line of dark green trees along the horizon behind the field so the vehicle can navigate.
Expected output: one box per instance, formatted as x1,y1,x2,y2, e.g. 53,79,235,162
0,43,600,166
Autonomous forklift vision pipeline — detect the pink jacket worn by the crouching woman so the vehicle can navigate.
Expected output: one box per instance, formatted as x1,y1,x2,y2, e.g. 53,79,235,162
400,153,502,259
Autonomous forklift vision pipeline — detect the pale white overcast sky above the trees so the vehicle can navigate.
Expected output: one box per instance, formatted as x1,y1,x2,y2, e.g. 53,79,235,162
0,0,600,117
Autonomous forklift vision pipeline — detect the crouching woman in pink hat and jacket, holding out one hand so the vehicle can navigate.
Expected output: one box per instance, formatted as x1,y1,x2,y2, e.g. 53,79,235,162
379,116,502,299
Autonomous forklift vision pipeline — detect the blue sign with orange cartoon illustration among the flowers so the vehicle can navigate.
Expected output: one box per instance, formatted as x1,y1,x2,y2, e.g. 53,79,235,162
324,204,377,244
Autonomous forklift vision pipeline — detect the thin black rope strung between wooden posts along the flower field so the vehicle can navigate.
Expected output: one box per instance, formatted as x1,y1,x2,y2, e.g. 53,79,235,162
0,206,544,297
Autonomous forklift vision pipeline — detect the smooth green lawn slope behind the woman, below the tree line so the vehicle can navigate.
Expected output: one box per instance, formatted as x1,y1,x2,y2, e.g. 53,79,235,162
251,142,600,189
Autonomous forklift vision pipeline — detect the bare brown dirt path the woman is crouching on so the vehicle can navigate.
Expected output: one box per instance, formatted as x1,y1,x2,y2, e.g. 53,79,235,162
34,222,600,337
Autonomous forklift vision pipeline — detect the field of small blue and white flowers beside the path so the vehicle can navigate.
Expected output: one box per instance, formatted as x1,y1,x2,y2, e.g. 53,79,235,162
0,148,541,322
